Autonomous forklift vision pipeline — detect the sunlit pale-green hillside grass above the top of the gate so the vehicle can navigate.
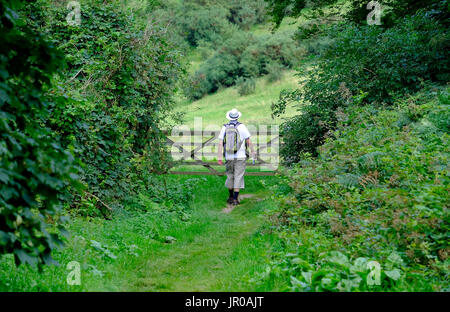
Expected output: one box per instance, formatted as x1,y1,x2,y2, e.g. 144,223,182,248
177,71,298,128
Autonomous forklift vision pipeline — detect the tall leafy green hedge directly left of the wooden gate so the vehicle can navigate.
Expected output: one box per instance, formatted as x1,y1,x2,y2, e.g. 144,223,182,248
23,1,184,215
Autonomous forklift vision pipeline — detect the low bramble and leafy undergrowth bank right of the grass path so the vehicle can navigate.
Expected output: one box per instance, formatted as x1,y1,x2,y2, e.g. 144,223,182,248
260,88,450,291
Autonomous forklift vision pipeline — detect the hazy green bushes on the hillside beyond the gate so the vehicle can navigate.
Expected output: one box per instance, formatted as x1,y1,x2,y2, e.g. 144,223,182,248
151,0,300,100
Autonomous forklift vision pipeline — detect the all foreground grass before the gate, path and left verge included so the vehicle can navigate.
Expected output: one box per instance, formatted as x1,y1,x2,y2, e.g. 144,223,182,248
0,176,284,291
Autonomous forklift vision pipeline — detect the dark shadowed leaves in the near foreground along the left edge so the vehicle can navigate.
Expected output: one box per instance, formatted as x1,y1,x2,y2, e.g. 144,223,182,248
0,1,81,265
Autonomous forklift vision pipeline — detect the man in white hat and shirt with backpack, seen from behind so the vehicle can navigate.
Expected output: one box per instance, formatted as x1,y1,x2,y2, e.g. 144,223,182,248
217,108,256,205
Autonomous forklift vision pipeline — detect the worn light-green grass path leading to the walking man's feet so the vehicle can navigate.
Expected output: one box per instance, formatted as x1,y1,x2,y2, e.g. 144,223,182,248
121,178,280,291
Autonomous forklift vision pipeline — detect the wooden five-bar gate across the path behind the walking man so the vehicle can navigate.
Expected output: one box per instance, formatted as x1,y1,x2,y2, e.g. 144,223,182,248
165,127,280,176
